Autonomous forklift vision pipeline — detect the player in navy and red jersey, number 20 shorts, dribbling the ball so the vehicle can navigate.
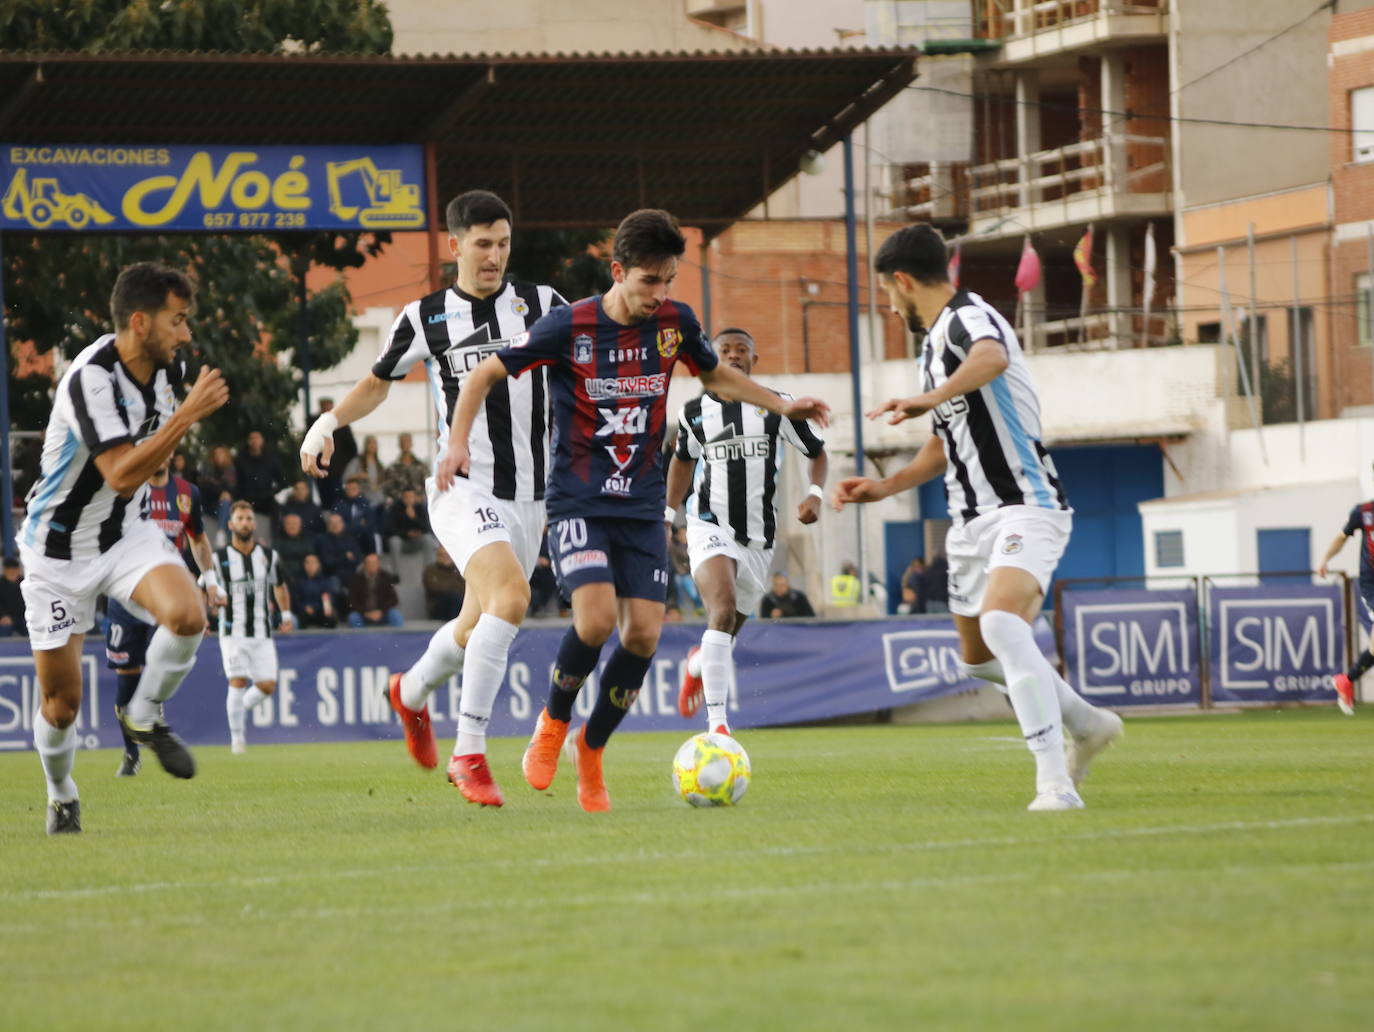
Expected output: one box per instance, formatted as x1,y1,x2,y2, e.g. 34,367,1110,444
436,209,830,811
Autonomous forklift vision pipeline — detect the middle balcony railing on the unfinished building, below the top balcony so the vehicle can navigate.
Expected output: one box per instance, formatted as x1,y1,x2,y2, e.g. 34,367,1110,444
969,133,1169,216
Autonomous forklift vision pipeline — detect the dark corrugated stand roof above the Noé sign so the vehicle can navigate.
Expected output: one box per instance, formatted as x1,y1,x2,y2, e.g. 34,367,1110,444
0,49,916,236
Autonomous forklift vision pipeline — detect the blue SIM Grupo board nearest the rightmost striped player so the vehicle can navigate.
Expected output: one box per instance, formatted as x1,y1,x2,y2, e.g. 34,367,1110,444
1061,590,1202,709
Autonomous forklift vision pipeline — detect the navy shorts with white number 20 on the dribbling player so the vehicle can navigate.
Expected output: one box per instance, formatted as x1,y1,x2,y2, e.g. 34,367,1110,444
548,517,668,602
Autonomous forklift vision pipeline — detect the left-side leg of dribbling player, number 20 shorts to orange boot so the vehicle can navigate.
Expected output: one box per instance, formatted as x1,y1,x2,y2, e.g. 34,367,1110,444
521,517,615,790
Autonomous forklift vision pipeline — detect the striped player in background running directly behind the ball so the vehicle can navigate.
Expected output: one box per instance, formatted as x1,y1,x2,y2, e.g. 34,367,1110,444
664,328,829,735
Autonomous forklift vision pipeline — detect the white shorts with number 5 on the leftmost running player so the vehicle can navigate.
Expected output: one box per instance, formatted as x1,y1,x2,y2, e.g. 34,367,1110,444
19,519,185,651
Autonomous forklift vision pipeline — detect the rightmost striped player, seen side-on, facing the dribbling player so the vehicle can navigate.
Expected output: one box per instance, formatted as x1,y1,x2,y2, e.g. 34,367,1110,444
834,224,1121,811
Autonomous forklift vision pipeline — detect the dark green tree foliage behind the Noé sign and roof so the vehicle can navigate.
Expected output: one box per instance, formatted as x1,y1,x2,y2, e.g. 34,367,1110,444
0,0,392,452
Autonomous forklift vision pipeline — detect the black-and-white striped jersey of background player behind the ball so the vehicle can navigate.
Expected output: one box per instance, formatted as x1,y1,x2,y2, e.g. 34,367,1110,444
677,392,826,548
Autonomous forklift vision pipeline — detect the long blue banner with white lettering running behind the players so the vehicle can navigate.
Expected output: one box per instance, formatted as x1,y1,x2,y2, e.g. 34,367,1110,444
0,618,1052,749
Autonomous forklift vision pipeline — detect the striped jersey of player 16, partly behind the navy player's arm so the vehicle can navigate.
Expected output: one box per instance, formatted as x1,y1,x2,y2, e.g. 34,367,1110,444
372,280,567,502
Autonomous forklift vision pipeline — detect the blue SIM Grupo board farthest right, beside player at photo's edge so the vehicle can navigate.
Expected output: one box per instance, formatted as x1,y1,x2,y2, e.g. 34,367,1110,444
1208,584,1345,702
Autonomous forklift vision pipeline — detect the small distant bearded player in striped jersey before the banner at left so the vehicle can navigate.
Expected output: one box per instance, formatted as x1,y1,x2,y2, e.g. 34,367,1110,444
214,500,295,753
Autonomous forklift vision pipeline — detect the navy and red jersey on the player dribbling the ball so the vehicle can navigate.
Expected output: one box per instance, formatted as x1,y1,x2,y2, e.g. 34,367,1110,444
497,295,717,522
